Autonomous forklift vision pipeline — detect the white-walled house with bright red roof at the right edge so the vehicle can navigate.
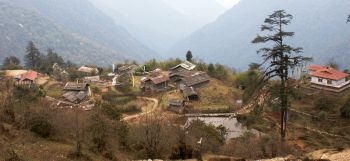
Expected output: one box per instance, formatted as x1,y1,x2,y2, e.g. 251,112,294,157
308,65,350,92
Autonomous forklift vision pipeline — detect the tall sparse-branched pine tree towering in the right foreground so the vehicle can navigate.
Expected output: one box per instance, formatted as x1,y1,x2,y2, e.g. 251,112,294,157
252,10,306,140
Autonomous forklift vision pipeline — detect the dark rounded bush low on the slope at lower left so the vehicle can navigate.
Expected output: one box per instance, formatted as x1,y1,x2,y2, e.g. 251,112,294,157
30,116,52,138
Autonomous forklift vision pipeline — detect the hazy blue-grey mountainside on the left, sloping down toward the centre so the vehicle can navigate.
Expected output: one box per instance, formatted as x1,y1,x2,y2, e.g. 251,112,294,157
0,0,156,65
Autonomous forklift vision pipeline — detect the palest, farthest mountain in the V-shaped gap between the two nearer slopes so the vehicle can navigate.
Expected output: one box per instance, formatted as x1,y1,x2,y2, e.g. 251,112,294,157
90,0,224,54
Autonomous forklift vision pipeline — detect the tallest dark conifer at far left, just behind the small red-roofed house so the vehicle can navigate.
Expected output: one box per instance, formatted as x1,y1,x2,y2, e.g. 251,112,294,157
25,41,40,69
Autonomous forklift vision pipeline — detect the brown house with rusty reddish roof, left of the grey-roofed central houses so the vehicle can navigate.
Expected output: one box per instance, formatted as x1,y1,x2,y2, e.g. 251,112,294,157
140,75,170,91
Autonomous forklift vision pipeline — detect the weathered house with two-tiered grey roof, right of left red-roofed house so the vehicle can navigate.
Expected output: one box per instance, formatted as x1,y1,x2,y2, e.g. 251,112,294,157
63,82,91,104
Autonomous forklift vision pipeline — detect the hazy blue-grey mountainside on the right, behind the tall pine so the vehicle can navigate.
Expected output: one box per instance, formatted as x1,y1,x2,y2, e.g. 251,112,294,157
169,0,350,69
